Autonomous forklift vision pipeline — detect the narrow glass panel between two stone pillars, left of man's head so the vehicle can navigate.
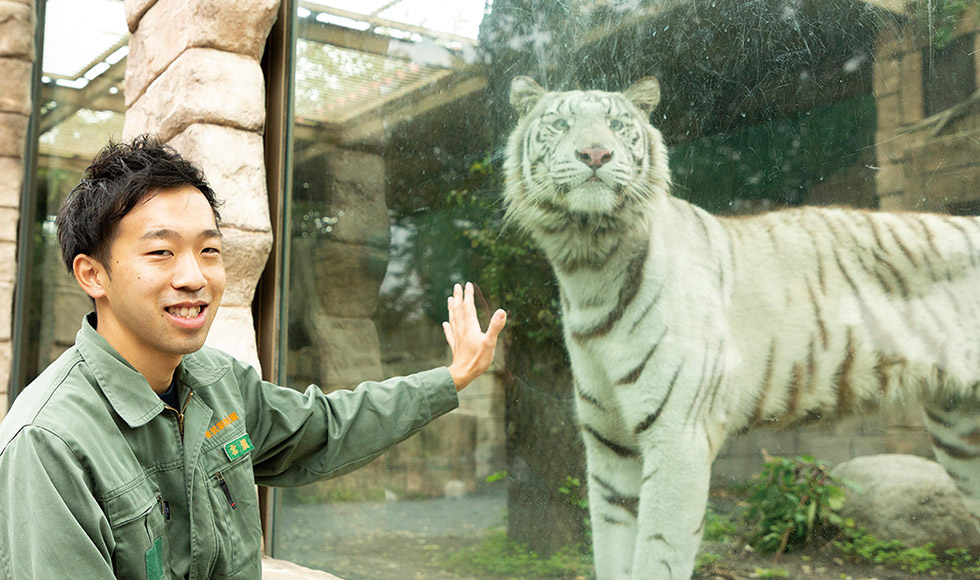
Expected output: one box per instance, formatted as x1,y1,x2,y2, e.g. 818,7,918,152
19,0,129,384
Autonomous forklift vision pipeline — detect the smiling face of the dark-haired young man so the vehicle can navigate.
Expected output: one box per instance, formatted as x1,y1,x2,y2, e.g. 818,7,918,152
96,186,225,371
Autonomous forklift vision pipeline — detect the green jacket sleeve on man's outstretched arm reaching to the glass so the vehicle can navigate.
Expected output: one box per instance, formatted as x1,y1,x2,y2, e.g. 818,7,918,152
234,367,459,486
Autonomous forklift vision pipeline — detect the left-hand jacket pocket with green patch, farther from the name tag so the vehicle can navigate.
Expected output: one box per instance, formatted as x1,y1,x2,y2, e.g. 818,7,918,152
103,480,167,580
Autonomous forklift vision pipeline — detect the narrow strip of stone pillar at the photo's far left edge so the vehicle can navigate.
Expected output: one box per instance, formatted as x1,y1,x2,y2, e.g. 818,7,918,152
0,0,34,419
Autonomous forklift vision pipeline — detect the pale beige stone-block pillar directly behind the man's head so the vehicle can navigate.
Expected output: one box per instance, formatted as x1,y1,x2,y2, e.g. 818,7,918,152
124,0,279,367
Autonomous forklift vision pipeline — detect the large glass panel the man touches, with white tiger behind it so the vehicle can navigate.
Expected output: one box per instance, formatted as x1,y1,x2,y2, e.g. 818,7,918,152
274,0,980,580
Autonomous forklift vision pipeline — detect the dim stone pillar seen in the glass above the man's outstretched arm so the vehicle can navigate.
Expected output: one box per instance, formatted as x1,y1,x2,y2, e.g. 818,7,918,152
289,146,390,392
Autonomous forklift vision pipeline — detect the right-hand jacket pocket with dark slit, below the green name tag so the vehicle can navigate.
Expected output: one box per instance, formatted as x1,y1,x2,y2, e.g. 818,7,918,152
208,448,262,578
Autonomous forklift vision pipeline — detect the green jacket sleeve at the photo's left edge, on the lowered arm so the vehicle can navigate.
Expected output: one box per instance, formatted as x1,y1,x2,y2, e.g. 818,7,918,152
0,426,115,580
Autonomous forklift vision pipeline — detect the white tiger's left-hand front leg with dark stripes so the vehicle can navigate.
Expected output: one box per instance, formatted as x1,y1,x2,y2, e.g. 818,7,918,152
578,393,641,580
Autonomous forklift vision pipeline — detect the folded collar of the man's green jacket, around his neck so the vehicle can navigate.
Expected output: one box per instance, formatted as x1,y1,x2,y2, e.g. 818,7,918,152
75,312,226,429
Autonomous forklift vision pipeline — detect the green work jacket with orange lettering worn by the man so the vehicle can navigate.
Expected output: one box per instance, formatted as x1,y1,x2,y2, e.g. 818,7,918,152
0,320,458,580
